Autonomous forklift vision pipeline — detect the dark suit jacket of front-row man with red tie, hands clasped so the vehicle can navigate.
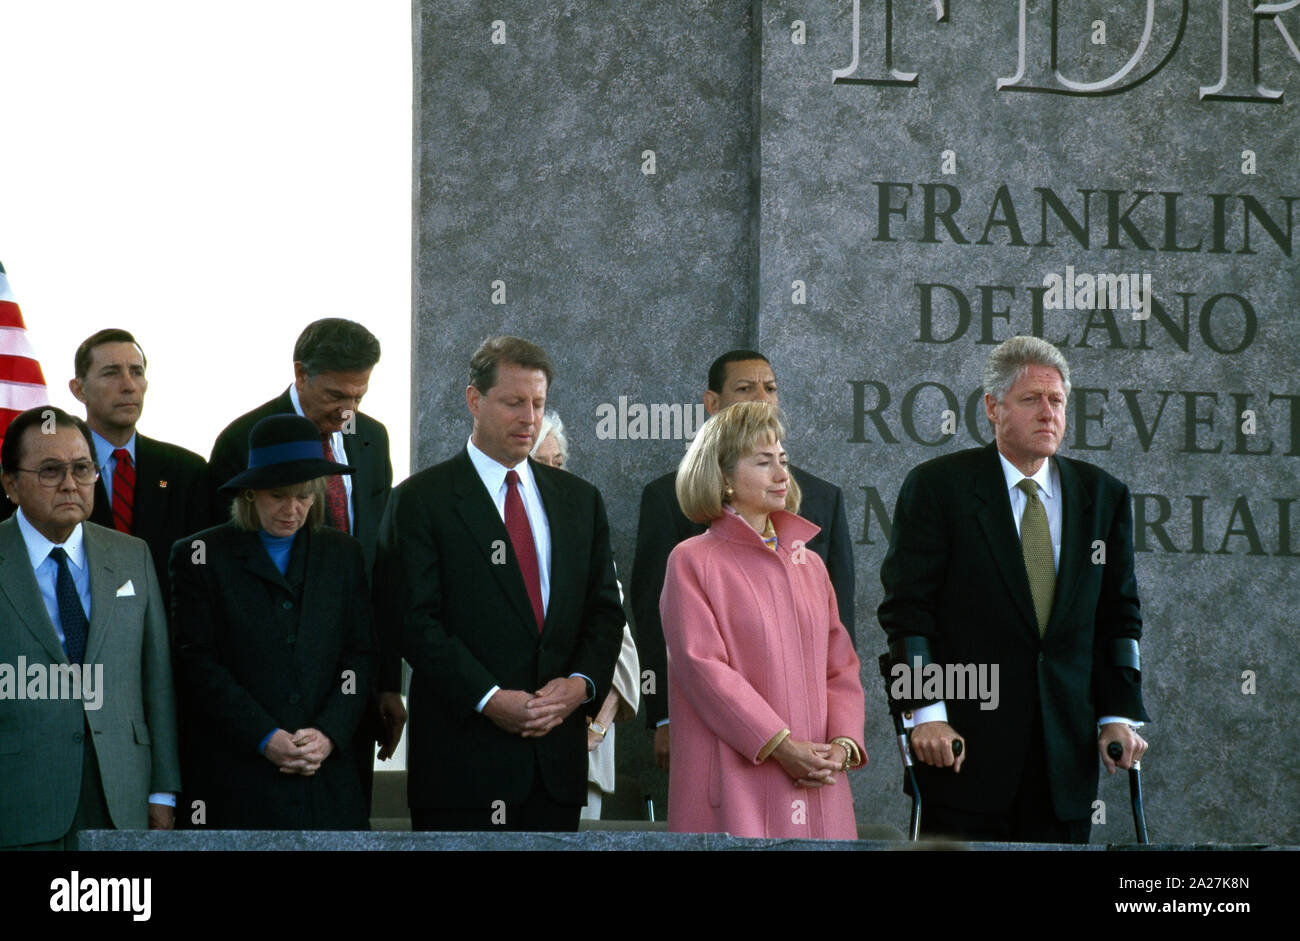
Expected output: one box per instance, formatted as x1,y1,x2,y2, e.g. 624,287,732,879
374,451,624,810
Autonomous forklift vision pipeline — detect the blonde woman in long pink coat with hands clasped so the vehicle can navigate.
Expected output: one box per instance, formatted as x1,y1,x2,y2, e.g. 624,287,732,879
659,402,867,840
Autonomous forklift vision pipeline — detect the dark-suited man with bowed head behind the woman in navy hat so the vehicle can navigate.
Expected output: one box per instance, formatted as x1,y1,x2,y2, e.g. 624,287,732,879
208,317,406,807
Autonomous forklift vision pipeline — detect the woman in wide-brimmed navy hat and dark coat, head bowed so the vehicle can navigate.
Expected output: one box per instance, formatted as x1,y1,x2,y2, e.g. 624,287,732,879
172,415,374,829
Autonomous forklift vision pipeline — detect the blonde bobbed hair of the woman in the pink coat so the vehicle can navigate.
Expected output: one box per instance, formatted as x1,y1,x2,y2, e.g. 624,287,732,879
677,402,801,522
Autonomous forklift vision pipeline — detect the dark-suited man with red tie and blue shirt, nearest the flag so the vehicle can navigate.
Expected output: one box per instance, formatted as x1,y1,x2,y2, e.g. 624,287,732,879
68,328,209,610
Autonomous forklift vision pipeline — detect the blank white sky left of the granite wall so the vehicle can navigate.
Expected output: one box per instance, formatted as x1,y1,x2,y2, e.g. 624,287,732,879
0,0,412,480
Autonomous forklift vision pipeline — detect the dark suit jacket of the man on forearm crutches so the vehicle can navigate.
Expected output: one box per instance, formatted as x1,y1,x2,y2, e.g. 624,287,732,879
879,445,1147,820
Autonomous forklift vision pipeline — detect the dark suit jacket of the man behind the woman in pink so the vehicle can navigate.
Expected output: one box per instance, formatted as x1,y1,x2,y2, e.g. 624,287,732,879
632,467,858,728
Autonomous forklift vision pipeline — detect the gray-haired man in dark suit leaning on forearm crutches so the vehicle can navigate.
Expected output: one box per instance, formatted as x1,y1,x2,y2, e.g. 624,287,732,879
879,337,1147,842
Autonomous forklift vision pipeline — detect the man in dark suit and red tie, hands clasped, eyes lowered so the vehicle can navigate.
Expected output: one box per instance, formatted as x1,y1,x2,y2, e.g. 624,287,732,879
374,337,623,831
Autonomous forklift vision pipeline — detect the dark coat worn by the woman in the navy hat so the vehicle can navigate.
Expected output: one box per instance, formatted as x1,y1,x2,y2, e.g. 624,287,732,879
172,522,374,829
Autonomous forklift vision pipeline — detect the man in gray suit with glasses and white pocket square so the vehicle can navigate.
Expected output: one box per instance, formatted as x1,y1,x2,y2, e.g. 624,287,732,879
0,406,181,849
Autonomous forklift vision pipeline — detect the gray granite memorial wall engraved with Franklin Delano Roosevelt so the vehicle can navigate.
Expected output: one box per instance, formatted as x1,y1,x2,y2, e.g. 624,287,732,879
412,0,1300,844
